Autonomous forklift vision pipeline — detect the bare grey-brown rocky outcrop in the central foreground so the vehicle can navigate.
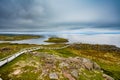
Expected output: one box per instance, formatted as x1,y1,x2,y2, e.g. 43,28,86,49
28,52,114,80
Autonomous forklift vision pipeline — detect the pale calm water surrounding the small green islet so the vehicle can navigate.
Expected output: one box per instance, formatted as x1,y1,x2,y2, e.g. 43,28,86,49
0,34,120,47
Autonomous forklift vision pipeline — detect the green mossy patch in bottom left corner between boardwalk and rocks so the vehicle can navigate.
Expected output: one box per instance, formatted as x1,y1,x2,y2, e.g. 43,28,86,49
0,54,40,80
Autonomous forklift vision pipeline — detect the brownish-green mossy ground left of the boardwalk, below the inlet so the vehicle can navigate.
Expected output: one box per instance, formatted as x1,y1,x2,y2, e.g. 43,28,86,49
0,43,37,59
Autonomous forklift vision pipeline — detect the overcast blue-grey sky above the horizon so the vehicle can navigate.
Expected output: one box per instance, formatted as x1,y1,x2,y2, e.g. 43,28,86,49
0,0,120,31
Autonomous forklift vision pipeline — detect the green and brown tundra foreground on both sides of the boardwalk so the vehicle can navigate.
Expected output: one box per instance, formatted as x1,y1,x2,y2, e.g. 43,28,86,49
0,43,120,80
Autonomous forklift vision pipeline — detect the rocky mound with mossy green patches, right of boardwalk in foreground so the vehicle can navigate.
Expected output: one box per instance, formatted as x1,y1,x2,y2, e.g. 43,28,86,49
0,52,114,80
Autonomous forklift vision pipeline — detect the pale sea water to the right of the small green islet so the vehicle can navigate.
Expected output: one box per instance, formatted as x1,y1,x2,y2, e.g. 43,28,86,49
58,34,120,47
